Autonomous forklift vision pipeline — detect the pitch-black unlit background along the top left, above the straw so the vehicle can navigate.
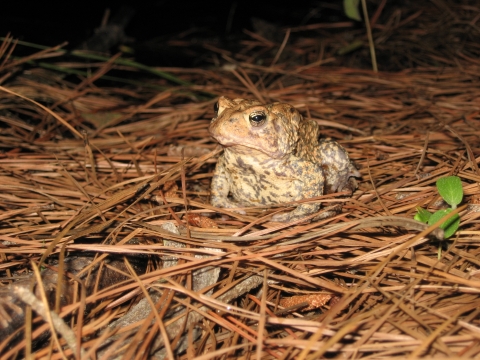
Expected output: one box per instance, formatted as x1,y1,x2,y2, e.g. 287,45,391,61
0,0,347,51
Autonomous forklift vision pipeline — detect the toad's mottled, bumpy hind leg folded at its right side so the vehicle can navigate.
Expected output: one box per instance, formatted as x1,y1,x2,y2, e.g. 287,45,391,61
317,139,361,194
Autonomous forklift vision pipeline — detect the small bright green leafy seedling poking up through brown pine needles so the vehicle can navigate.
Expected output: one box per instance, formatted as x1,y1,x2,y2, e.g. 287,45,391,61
414,176,463,257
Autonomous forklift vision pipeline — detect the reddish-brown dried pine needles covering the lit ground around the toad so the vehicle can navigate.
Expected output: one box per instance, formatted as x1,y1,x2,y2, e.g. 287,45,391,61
0,15,480,359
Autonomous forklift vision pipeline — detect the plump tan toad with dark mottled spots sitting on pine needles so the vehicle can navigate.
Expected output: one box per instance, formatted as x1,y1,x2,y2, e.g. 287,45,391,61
209,97,360,222
